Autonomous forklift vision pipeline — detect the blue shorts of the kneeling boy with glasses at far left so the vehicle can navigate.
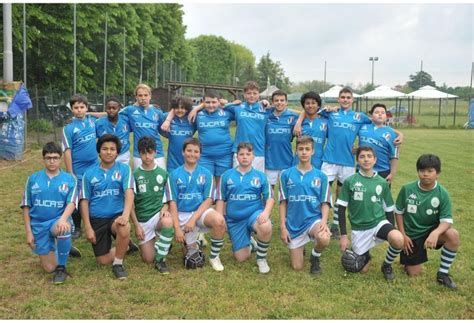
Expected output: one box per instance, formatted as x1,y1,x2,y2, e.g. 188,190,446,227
30,217,74,255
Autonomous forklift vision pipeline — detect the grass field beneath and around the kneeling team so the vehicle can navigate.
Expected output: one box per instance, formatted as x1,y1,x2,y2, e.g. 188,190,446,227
0,129,474,319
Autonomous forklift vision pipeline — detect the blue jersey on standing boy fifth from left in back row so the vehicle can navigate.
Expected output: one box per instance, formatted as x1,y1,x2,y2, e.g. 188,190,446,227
196,108,234,158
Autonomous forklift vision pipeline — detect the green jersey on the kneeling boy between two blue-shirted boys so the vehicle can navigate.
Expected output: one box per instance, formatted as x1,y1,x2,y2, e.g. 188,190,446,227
133,165,168,222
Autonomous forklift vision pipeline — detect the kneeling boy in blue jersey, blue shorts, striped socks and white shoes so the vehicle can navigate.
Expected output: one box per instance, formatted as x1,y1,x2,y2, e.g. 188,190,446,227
216,142,274,274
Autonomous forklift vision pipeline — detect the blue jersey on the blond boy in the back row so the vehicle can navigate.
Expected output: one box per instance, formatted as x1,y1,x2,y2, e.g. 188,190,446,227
120,105,165,158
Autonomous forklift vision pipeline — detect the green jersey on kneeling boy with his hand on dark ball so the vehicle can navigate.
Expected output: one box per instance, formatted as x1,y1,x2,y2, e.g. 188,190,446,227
337,172,395,231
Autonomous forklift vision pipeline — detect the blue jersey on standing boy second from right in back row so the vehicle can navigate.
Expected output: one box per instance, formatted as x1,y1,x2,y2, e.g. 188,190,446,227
321,109,372,167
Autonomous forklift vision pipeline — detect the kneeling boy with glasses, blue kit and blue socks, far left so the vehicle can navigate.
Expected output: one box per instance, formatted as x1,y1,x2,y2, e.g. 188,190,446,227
21,142,78,284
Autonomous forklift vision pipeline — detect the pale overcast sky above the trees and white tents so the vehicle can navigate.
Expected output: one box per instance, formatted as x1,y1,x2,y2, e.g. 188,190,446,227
183,3,474,86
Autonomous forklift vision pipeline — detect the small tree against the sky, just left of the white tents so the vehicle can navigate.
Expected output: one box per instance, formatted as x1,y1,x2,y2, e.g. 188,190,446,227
257,52,291,92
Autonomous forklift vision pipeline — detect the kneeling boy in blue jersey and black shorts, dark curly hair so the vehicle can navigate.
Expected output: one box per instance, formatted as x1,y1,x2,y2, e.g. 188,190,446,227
80,134,134,279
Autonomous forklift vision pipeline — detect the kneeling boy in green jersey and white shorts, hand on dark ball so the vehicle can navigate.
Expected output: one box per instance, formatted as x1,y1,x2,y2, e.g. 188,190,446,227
337,146,403,281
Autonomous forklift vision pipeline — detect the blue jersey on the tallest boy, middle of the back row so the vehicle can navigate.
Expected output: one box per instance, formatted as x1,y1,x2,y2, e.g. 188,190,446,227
225,102,273,157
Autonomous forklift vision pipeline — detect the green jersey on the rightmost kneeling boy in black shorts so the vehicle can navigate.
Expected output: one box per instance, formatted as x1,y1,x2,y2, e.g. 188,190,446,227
395,181,453,239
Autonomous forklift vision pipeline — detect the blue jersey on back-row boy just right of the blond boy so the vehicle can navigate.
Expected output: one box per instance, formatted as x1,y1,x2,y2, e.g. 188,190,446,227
160,113,196,172
